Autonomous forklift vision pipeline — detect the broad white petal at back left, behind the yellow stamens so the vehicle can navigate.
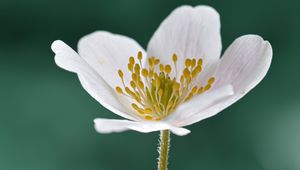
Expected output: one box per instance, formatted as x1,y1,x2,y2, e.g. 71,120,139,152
78,31,146,88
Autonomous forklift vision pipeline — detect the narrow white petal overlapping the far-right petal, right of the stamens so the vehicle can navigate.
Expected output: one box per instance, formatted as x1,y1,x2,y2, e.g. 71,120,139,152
164,85,234,126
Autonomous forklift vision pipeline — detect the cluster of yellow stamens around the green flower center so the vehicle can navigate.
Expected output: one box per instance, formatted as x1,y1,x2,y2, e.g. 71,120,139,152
116,52,215,121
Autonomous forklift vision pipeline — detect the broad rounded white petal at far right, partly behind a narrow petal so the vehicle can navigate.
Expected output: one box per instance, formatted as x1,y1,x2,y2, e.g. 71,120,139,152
179,35,272,125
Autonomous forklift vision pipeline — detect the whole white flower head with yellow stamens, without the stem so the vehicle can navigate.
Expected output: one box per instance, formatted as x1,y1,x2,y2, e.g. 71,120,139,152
52,6,272,135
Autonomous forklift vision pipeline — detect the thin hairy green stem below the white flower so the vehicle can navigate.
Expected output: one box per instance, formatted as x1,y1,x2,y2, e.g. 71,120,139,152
157,130,170,170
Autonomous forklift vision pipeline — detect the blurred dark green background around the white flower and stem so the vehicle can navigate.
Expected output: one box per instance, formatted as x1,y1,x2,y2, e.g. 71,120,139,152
0,0,300,170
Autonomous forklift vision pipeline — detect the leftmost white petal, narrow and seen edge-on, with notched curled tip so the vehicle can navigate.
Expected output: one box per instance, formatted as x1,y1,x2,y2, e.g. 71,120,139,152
51,40,138,120
